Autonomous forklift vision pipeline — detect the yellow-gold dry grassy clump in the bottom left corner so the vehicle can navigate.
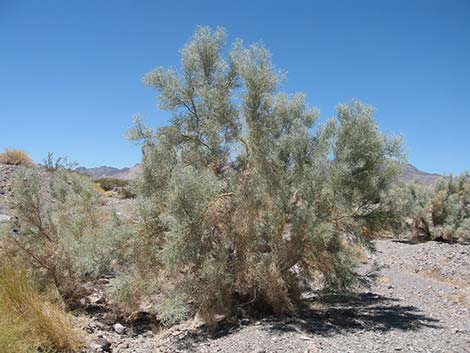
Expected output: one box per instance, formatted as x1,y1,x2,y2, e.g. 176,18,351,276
0,263,84,353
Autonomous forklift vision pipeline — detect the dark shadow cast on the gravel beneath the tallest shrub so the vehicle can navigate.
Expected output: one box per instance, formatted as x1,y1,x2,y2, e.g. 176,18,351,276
173,293,440,348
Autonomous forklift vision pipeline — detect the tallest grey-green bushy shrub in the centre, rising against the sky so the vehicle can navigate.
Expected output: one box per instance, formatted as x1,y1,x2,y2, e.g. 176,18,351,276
130,27,402,319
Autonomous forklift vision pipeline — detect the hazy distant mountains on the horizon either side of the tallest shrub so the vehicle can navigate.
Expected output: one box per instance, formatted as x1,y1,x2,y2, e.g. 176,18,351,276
77,164,442,185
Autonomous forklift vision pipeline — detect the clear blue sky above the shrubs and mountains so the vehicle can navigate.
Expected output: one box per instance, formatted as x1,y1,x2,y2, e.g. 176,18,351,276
0,0,470,173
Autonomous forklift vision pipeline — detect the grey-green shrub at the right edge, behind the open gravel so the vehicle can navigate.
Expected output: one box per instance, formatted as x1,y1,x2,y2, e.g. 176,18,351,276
404,173,470,241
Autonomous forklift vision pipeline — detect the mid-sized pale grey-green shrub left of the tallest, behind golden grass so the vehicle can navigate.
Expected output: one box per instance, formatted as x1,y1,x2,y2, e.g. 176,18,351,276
2,169,130,304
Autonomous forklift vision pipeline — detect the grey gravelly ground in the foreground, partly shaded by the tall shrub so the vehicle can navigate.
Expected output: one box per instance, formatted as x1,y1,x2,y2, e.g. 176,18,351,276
83,240,470,353
